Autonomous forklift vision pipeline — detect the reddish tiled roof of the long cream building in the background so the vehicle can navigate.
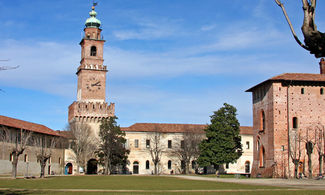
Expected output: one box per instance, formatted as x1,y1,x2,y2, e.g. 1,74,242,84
121,123,253,135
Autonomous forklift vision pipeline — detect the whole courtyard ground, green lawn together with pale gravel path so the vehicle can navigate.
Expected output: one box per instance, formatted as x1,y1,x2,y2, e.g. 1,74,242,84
0,175,325,194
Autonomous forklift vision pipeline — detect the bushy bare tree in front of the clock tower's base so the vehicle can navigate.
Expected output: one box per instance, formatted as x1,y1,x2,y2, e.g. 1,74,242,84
67,122,98,174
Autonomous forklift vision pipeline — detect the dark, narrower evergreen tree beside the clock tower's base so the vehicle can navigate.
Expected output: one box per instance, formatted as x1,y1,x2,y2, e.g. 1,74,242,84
97,116,130,175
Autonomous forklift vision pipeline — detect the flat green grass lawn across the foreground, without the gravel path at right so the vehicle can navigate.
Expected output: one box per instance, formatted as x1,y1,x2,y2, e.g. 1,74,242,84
0,176,325,195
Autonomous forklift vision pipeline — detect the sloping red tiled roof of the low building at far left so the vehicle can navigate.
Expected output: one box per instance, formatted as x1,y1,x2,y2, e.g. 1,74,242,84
0,115,60,136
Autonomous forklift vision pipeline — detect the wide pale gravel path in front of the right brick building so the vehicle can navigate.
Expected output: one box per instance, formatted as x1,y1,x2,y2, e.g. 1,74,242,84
174,175,325,190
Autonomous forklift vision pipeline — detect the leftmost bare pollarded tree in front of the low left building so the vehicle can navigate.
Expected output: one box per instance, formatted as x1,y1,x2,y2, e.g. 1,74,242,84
0,126,32,178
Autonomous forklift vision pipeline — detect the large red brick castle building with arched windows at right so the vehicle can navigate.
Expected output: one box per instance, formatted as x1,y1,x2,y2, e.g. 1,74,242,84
246,59,325,178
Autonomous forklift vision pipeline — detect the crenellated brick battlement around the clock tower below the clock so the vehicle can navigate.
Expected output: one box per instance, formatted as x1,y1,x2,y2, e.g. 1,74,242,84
68,101,115,122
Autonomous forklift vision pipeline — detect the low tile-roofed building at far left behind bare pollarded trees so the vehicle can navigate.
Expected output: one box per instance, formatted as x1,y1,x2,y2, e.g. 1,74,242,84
0,115,65,176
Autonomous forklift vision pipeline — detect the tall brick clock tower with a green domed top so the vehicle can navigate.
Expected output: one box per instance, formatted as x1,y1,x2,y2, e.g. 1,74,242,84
68,6,115,135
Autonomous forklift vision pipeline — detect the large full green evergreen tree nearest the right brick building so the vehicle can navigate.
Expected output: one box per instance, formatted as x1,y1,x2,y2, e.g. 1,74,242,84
198,103,242,168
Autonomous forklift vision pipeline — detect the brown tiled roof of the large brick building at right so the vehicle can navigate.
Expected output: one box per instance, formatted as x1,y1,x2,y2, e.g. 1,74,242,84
246,73,325,92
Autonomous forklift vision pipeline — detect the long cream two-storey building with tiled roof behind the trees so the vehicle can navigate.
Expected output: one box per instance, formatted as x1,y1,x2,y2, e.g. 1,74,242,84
121,123,253,174
